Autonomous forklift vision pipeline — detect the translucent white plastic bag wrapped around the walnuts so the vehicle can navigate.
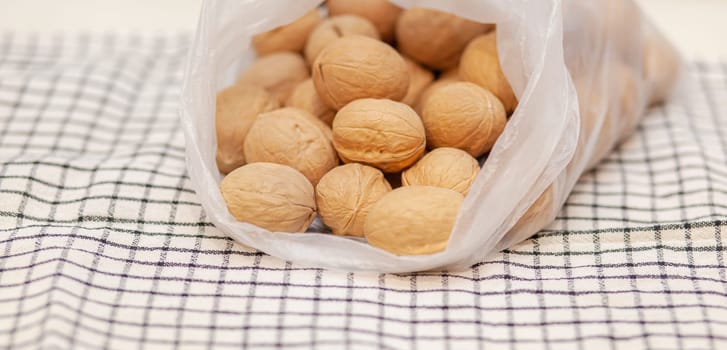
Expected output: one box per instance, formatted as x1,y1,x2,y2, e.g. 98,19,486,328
180,0,679,273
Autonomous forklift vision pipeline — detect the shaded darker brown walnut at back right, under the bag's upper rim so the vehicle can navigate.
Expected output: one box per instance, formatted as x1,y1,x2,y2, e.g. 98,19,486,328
396,7,493,70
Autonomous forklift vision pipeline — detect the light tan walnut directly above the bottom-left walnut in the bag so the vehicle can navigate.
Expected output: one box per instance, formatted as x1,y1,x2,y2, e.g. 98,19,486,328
244,107,338,185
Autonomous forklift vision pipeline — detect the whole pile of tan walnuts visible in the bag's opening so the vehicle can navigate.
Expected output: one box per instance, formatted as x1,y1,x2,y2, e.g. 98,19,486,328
216,0,517,255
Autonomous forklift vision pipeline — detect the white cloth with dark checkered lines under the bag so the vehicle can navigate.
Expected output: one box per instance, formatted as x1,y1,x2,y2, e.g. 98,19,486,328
0,35,727,349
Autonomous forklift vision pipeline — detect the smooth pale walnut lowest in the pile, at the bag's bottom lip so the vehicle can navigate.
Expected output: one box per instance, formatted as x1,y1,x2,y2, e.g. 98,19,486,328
364,186,464,255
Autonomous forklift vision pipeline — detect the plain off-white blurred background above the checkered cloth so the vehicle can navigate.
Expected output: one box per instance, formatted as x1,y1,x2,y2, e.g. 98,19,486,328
0,0,727,61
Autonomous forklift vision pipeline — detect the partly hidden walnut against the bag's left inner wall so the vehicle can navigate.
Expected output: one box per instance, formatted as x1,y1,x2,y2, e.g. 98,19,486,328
215,85,279,174
